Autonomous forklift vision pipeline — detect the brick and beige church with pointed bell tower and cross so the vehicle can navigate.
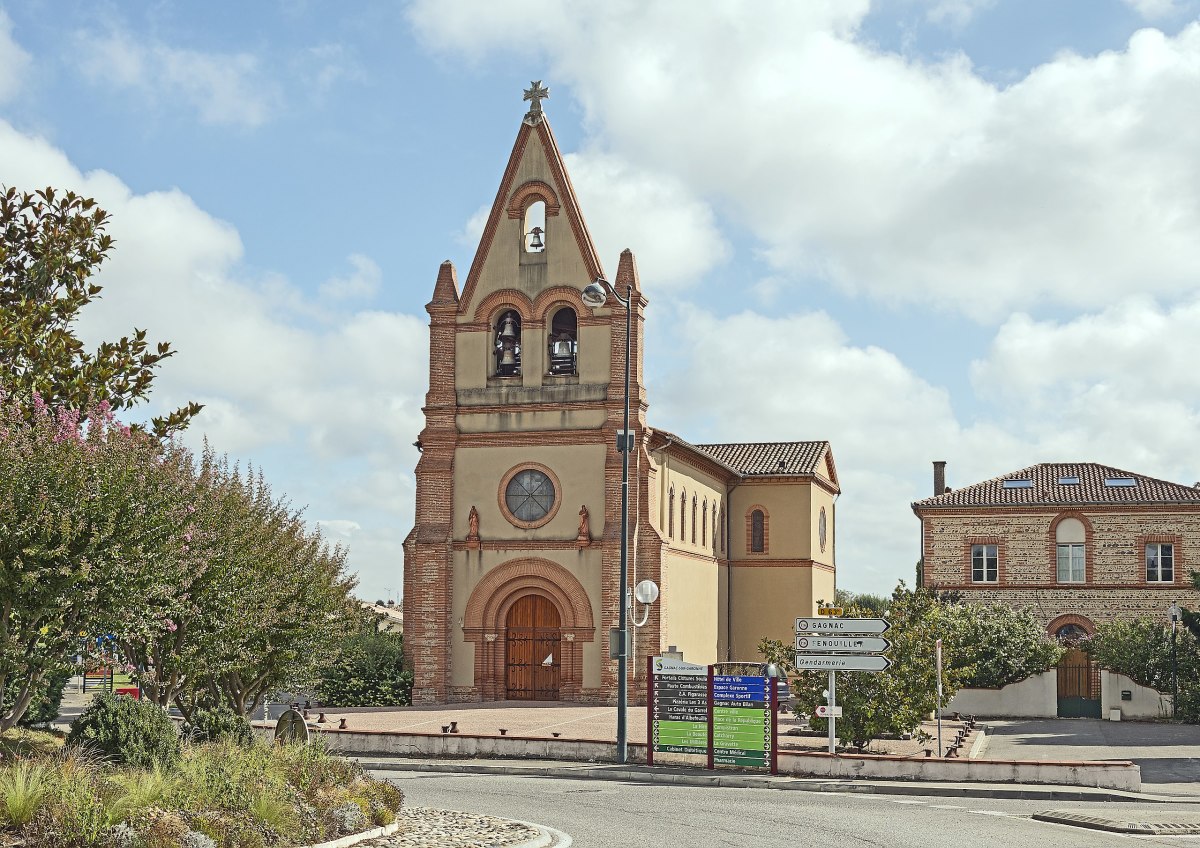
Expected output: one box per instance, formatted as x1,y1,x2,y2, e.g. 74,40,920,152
403,83,840,704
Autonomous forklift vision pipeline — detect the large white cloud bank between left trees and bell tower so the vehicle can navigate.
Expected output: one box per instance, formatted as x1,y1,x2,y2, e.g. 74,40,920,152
0,121,428,599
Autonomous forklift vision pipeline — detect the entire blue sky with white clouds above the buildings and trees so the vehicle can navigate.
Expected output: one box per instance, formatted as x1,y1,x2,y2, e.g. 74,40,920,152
0,0,1200,599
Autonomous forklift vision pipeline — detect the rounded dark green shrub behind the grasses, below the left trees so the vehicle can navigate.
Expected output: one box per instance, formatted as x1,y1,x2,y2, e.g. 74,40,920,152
67,692,180,769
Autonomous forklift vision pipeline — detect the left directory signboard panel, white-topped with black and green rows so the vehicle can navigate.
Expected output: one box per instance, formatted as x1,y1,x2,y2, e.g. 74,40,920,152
649,656,708,753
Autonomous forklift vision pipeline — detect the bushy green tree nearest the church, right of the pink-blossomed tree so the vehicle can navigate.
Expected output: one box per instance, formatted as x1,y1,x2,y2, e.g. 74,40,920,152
121,451,354,716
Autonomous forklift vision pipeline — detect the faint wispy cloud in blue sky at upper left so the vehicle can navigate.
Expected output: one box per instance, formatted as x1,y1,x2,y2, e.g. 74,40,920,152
76,28,281,127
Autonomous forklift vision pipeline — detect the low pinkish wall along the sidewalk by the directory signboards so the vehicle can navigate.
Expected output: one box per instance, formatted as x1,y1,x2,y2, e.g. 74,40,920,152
270,727,1141,792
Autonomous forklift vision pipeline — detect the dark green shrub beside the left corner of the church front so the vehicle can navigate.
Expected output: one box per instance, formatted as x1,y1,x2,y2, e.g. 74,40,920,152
317,630,413,706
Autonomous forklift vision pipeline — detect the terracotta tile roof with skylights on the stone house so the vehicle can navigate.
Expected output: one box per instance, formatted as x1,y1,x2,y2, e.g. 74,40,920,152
912,462,1200,510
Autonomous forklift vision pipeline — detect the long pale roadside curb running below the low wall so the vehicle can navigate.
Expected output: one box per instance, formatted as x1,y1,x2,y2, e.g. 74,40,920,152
355,759,1161,806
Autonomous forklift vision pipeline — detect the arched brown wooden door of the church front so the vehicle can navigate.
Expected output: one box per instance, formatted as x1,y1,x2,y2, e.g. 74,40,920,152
504,595,562,700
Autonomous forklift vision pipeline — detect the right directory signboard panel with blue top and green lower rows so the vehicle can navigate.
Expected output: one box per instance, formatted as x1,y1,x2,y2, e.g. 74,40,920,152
713,674,773,769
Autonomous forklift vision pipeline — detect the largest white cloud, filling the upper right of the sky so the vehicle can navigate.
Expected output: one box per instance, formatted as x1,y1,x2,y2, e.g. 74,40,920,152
412,0,1200,320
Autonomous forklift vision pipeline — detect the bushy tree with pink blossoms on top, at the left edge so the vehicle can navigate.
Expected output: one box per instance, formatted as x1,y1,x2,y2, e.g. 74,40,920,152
0,393,186,733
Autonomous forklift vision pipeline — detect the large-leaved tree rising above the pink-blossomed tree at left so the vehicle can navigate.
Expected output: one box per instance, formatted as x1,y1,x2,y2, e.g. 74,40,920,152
0,188,202,437
